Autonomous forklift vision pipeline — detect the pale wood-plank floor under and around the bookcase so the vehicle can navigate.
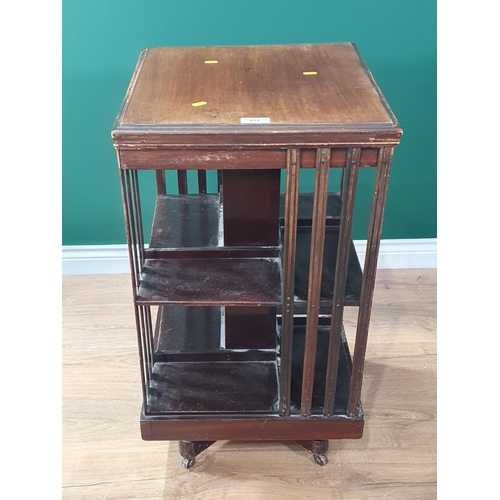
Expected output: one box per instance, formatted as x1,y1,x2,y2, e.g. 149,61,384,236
62,269,436,500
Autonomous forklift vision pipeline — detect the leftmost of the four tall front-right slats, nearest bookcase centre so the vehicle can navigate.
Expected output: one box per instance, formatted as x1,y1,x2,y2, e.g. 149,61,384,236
280,149,300,416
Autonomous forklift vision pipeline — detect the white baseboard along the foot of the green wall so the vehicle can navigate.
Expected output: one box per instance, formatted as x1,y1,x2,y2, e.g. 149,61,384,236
62,238,437,274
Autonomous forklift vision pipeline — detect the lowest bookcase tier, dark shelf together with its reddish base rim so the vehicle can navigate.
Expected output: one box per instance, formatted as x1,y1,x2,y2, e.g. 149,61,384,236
141,306,364,441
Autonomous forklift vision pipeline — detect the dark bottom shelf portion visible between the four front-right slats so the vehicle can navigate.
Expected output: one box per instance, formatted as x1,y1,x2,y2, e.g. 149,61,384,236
290,325,351,415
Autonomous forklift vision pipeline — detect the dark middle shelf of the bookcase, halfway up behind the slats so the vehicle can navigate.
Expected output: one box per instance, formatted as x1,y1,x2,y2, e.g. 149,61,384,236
136,193,362,306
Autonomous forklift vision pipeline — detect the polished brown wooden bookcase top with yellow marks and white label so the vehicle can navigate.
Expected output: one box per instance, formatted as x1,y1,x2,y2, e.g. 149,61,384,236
111,43,399,146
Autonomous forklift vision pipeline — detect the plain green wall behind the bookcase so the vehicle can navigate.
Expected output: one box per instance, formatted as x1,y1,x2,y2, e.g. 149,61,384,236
62,0,436,245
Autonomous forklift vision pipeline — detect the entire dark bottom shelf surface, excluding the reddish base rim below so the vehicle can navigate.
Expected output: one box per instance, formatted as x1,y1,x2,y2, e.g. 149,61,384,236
148,306,351,415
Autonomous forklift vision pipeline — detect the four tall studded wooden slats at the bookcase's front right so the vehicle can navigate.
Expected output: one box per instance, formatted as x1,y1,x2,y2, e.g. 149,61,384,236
280,147,382,417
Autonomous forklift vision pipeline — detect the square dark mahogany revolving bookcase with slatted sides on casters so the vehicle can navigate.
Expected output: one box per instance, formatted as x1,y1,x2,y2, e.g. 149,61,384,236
112,43,402,467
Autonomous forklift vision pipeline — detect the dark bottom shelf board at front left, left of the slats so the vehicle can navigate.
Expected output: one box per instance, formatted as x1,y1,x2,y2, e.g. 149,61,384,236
147,361,278,414
